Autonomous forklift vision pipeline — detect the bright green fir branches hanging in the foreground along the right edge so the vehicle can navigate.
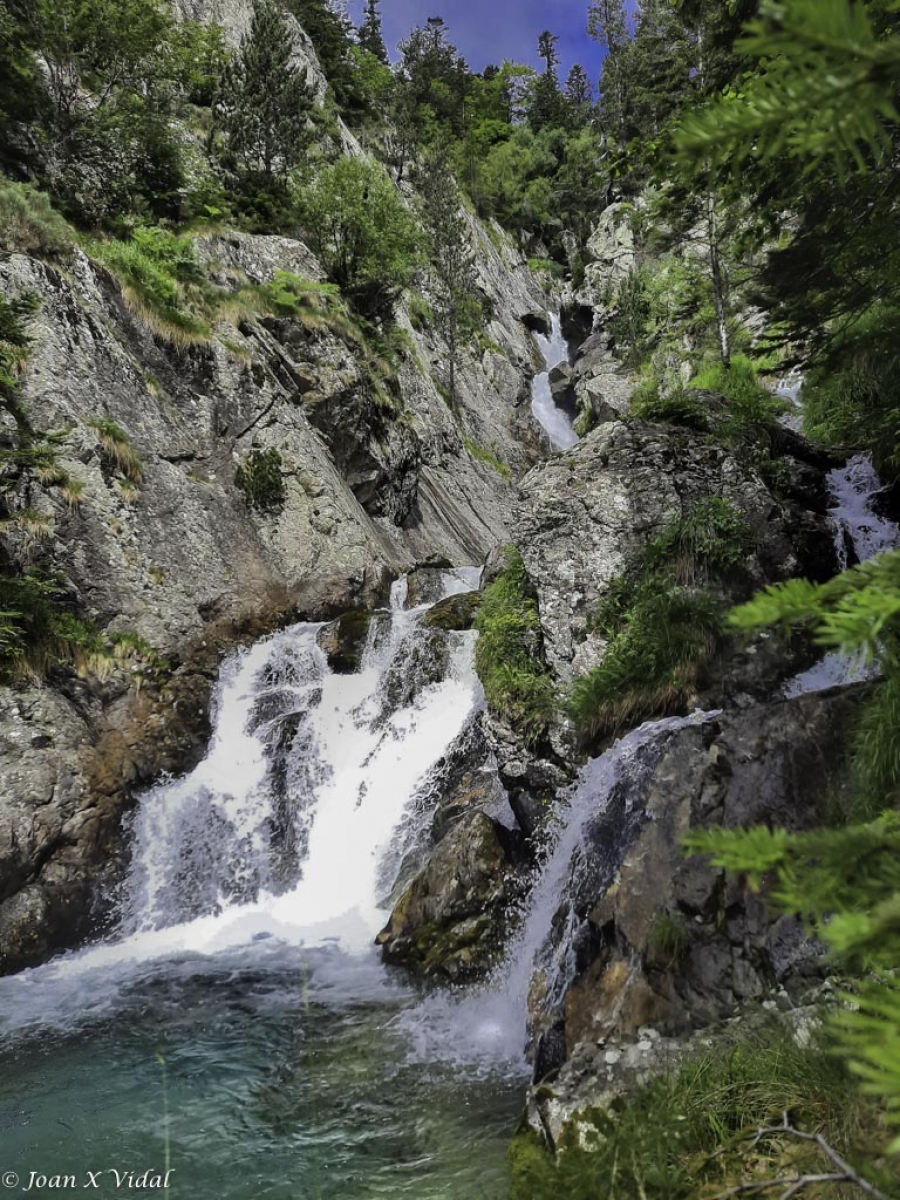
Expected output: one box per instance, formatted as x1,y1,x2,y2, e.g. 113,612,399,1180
676,0,900,1161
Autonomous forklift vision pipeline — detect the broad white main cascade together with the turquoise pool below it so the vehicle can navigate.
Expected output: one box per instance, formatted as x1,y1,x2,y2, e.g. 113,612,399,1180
0,570,521,1200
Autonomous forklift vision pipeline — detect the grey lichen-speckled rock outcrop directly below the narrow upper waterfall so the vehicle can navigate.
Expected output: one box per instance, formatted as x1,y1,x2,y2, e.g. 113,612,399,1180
516,420,826,680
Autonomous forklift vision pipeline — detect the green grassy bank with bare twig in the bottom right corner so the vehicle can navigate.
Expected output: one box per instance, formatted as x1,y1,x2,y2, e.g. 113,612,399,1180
510,1026,890,1200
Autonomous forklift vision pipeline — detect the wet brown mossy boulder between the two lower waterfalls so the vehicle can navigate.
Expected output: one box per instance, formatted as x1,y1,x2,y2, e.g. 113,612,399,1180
378,810,509,979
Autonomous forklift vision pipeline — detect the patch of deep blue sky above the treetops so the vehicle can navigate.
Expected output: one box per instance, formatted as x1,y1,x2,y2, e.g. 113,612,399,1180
349,0,602,84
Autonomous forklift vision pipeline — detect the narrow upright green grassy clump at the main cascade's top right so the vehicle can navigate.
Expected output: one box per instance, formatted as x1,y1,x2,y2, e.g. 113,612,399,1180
475,546,557,745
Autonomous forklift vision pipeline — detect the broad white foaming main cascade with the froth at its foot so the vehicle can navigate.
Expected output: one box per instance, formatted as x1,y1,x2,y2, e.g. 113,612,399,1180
0,568,482,1026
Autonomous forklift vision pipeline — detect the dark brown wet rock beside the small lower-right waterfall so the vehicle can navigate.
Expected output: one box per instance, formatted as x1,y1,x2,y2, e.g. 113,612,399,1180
532,689,862,1052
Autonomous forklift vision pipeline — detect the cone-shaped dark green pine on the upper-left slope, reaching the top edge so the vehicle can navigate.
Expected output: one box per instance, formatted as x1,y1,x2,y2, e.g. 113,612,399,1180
215,0,313,181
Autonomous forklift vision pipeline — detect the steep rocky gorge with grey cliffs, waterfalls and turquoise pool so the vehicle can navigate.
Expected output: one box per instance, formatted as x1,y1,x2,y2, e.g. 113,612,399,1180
0,0,900,1200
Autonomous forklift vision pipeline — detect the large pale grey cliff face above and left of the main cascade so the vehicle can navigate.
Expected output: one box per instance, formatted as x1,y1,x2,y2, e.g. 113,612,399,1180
0,180,540,971
